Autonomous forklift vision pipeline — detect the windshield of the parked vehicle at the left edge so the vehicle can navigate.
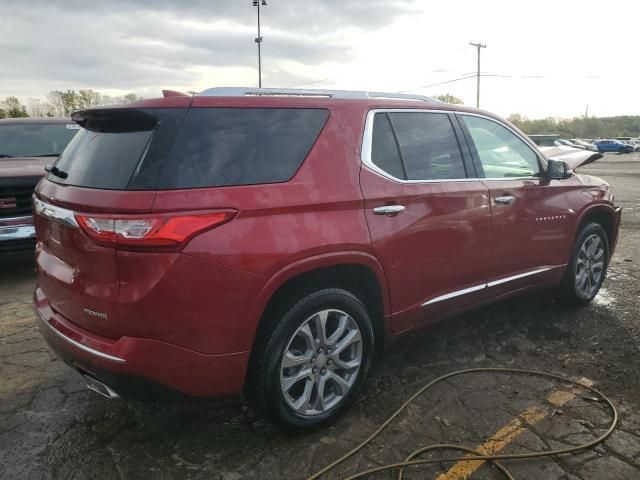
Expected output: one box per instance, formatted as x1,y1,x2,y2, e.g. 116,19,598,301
0,122,78,158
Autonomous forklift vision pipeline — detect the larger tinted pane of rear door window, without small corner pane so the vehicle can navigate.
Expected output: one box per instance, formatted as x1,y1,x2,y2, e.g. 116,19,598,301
389,112,467,180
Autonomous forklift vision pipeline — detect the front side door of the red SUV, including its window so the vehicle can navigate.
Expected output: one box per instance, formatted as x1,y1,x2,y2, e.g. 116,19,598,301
458,114,575,295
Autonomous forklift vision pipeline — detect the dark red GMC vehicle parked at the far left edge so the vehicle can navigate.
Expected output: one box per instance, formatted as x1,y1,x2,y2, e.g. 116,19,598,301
0,118,79,256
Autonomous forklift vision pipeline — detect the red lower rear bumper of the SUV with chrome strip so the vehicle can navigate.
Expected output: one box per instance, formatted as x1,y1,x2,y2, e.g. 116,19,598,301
34,288,249,399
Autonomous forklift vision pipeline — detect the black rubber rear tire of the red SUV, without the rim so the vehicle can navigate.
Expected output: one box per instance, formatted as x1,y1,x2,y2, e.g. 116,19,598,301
247,288,374,431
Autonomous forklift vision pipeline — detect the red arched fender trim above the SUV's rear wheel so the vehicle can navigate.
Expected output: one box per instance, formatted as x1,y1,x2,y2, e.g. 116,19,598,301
251,250,391,342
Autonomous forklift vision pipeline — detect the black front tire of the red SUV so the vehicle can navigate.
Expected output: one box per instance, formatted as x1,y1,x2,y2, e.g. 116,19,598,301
559,222,609,306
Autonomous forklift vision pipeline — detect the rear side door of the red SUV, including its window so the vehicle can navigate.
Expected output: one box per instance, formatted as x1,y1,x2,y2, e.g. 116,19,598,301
360,110,491,331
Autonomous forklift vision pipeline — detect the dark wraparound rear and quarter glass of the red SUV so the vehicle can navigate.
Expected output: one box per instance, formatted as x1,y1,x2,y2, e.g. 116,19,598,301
47,108,329,190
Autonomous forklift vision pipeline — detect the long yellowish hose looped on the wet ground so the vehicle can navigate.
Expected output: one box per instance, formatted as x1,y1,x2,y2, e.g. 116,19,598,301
307,368,618,480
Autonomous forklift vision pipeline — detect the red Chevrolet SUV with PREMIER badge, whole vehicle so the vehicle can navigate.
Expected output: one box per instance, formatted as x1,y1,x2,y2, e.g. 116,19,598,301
34,89,620,428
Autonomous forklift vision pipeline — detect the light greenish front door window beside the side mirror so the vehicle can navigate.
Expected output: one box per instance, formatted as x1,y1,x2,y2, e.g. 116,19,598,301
462,115,540,178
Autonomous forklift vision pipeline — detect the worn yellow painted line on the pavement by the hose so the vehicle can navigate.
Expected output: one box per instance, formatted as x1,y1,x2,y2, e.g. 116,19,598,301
437,378,593,480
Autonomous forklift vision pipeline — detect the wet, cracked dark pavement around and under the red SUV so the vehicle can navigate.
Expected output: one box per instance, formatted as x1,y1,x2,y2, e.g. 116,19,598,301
0,154,640,480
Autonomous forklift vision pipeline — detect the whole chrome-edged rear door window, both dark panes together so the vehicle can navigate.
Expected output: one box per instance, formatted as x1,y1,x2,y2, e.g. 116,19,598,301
371,112,467,180
